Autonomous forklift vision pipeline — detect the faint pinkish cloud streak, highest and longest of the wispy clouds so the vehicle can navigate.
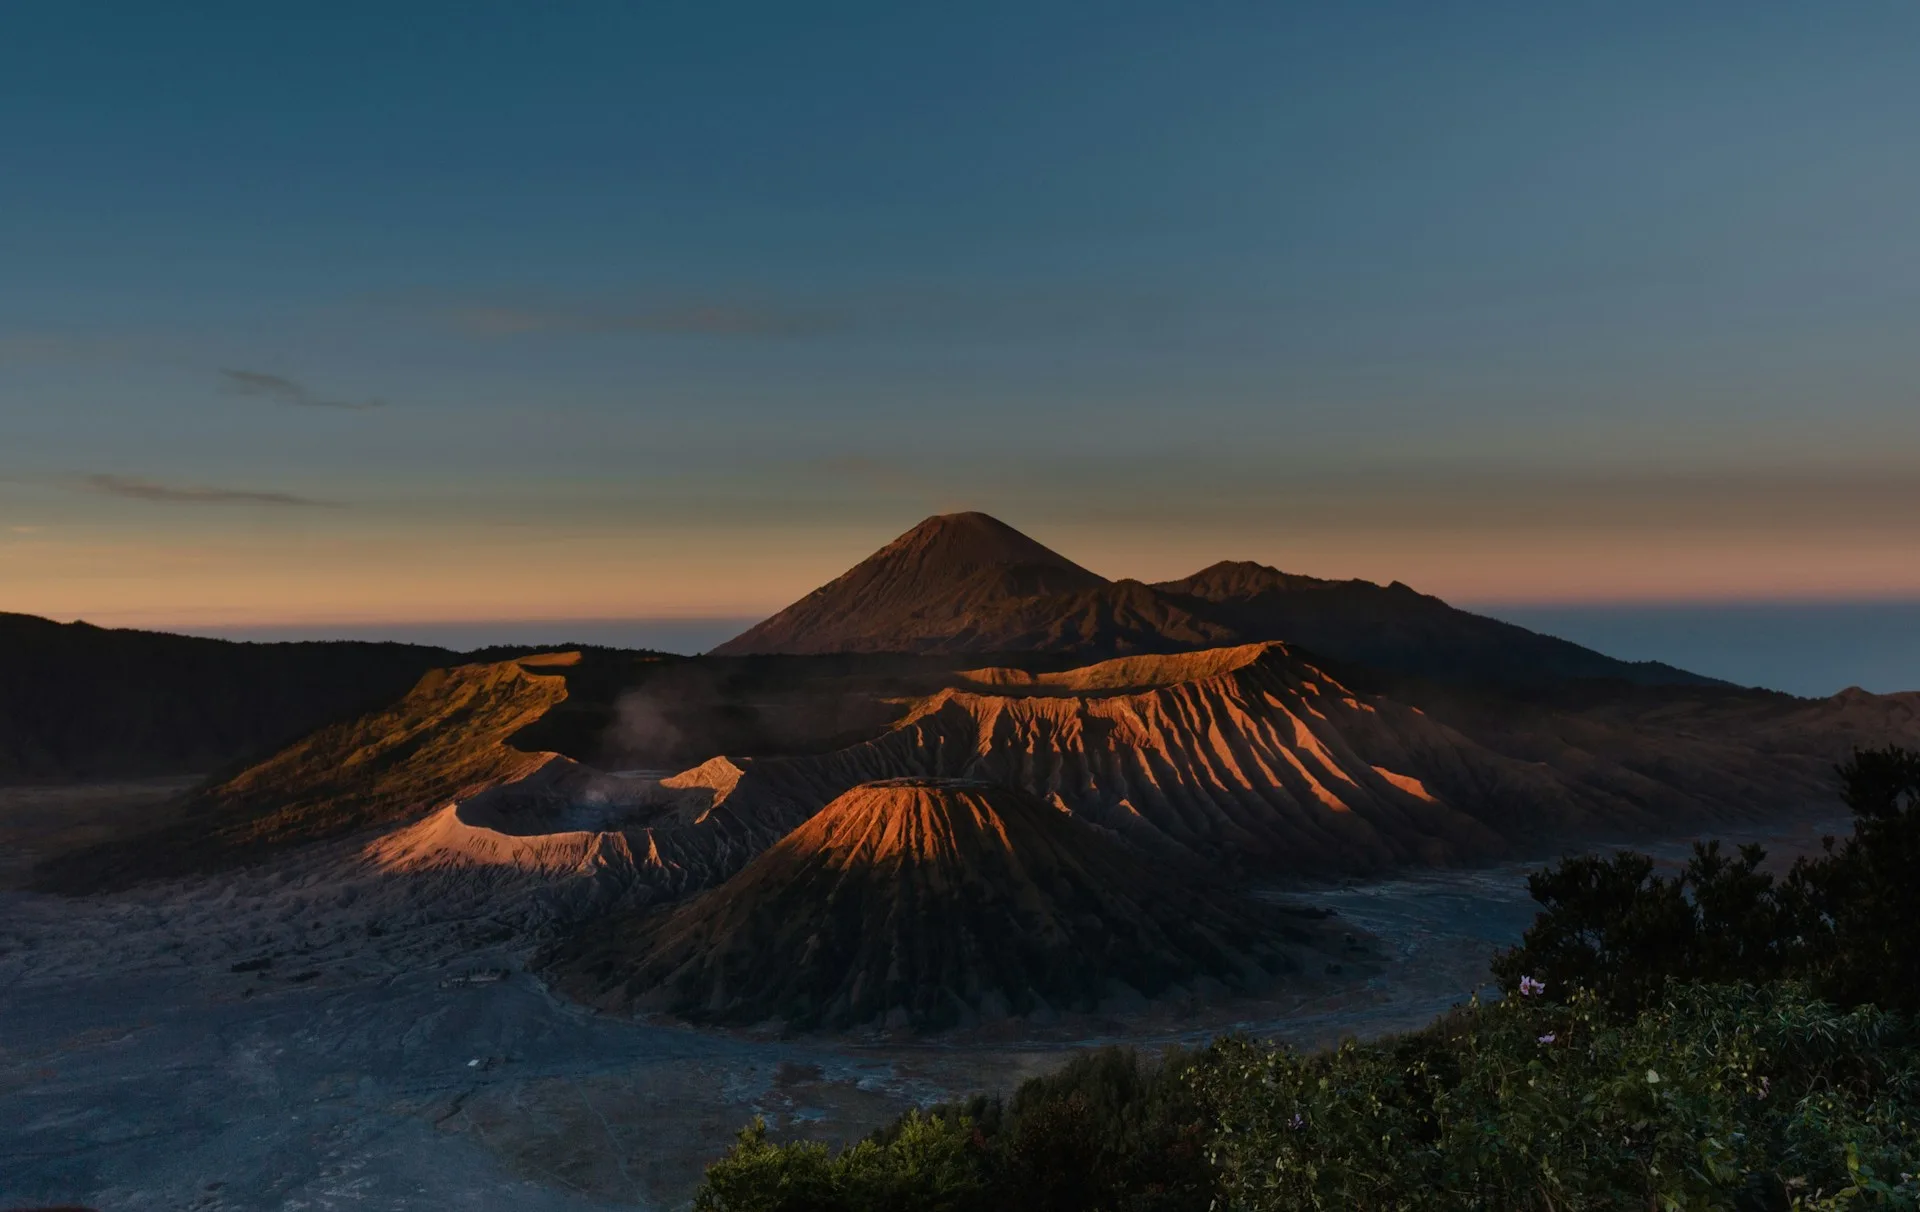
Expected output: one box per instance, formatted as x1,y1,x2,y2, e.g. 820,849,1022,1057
444,303,847,338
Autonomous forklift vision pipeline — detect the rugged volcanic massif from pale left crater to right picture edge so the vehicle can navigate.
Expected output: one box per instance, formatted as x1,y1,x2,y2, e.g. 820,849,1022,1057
367,643,1920,910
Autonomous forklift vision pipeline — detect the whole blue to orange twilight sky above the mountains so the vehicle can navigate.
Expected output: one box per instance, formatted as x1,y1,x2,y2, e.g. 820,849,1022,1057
0,0,1920,655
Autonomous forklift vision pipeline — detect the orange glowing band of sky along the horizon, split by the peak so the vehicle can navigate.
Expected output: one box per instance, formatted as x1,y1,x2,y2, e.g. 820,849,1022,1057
0,526,1920,628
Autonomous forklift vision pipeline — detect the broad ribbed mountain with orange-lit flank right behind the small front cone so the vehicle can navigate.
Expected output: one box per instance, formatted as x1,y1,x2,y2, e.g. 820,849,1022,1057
695,643,1712,874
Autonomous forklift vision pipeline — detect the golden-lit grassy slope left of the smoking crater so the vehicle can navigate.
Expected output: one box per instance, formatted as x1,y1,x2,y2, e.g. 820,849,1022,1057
36,653,574,891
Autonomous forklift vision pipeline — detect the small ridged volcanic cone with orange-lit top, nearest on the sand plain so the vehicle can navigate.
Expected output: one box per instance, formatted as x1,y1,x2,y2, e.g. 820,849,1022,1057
551,780,1308,1028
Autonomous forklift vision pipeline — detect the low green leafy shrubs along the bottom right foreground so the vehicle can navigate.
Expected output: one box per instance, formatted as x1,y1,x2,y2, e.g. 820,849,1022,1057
695,985,1920,1212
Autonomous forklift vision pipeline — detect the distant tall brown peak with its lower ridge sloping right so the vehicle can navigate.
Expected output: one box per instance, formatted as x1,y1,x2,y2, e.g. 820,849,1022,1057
714,513,1720,686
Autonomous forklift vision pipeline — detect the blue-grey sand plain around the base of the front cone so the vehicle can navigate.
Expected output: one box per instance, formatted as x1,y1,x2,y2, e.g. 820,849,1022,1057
0,797,1839,1212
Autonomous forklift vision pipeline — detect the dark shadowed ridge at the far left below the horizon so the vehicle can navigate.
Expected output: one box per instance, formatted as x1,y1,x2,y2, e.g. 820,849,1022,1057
0,615,457,782
